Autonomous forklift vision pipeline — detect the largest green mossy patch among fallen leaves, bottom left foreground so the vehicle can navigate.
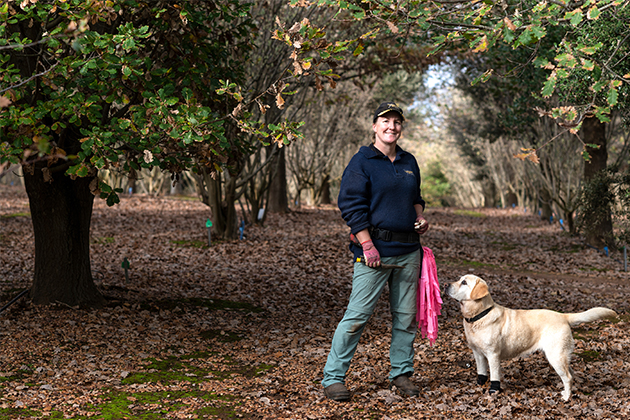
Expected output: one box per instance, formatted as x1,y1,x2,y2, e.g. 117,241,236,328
0,352,275,420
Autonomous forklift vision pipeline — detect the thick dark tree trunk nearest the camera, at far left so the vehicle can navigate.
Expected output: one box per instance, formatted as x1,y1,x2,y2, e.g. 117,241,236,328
23,165,104,307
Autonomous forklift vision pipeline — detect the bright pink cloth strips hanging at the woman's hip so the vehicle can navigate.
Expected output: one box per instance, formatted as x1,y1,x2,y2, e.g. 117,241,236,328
416,247,442,345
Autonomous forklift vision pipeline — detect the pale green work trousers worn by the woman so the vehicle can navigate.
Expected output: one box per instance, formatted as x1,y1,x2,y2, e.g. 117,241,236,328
322,249,422,387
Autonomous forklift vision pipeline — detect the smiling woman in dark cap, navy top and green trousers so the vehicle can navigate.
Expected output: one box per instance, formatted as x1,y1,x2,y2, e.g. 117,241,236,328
322,102,429,401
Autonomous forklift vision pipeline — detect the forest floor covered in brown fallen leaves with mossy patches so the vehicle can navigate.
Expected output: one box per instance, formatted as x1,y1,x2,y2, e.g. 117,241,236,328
0,186,630,419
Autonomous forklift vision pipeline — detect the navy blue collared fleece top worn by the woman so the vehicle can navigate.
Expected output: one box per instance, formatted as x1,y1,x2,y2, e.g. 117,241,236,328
337,145,425,258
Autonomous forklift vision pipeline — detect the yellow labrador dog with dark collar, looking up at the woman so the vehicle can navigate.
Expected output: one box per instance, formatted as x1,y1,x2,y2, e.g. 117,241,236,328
447,274,617,401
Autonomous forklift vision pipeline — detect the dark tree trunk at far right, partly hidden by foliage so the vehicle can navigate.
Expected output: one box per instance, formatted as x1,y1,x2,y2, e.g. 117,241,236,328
582,117,615,249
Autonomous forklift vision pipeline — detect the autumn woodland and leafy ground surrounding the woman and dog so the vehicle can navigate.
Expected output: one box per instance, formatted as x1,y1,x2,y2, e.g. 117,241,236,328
0,0,630,419
